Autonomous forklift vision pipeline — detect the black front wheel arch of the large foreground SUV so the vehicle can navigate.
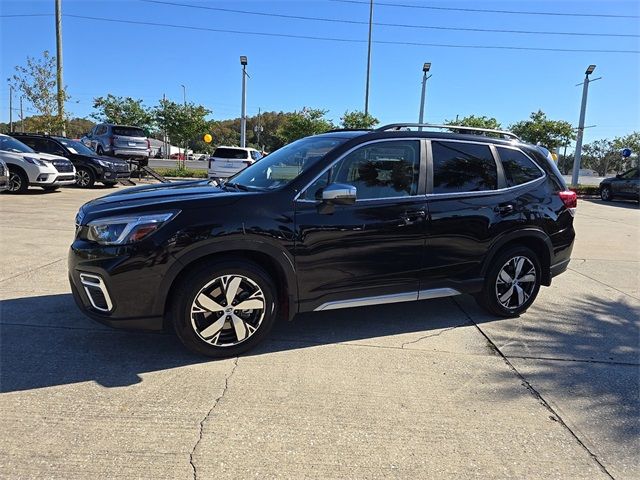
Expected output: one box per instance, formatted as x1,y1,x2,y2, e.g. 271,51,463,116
157,242,298,322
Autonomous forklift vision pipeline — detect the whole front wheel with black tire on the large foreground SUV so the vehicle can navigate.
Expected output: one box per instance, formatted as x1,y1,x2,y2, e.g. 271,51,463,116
171,260,278,358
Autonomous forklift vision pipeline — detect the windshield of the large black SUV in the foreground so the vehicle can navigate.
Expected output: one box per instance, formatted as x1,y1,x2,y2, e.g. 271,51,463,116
229,137,347,190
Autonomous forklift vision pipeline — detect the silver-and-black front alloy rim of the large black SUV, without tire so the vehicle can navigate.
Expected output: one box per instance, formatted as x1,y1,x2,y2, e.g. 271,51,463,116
191,275,266,347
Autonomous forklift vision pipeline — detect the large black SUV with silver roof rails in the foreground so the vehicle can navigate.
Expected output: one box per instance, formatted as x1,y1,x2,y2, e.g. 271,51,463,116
69,124,576,357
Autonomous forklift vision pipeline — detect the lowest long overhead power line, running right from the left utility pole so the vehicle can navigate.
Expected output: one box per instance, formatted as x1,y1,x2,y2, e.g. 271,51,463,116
64,14,640,54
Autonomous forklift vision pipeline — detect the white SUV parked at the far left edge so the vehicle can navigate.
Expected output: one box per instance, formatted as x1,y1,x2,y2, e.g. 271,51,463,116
0,134,76,193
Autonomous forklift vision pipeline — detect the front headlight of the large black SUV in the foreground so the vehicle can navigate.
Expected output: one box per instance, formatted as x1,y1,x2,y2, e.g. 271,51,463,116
87,211,179,245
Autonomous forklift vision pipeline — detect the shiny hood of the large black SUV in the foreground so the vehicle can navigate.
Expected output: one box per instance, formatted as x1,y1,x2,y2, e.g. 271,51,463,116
76,180,242,223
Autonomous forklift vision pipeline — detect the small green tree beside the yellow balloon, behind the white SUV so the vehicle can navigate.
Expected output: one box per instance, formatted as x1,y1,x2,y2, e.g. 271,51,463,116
153,100,211,164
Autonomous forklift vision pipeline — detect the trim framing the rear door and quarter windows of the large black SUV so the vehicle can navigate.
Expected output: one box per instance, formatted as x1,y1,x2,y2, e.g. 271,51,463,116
426,138,547,198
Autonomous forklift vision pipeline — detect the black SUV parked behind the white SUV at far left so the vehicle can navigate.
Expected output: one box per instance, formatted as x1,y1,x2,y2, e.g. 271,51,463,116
11,132,130,188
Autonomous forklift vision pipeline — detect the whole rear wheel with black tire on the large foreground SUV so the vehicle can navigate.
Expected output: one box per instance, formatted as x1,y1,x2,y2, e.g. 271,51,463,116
475,246,542,317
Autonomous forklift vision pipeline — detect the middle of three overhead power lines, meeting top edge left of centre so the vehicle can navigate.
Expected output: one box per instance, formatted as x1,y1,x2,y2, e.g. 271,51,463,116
140,0,640,37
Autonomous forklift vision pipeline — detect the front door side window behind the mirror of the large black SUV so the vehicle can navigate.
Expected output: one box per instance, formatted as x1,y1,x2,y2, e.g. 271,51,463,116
302,140,420,200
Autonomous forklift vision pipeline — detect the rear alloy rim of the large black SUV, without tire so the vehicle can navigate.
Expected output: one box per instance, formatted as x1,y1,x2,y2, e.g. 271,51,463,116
496,256,537,310
